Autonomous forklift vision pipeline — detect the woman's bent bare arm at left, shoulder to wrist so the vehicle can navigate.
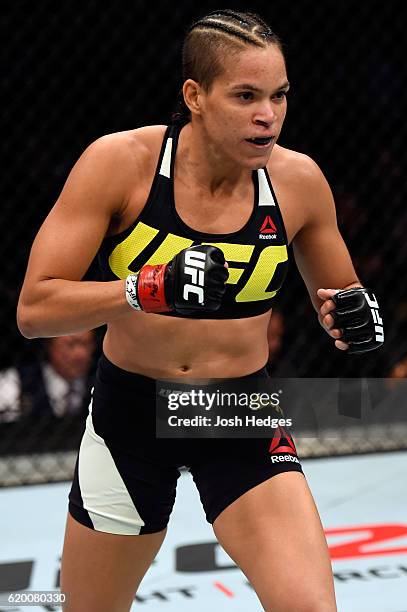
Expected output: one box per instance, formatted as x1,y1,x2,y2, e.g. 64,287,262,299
17,134,145,338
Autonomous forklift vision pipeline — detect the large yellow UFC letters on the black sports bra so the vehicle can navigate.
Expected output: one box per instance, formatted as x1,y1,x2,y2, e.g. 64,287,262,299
109,221,288,302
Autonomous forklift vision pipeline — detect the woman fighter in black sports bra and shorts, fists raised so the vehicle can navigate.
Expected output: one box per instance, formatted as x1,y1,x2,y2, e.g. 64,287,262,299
18,10,382,612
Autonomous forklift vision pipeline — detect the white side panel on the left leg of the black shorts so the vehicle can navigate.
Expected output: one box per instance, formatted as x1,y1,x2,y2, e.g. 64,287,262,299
78,412,144,535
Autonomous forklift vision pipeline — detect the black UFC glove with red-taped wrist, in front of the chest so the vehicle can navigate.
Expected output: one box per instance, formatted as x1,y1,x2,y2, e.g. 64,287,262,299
126,245,229,316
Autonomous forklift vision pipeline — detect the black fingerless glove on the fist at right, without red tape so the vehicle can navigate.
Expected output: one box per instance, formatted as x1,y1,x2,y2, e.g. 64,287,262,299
330,287,384,355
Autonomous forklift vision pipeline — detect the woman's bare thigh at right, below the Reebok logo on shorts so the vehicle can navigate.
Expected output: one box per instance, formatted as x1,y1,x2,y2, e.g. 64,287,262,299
213,472,336,612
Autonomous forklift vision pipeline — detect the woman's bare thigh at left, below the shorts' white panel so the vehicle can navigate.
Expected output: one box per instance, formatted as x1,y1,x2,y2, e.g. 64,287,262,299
61,514,166,612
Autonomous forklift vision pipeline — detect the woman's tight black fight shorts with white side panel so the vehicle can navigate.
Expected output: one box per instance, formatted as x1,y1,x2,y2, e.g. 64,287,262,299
69,356,302,535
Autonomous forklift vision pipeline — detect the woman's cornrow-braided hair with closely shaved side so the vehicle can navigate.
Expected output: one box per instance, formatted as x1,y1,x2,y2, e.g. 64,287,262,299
171,9,282,124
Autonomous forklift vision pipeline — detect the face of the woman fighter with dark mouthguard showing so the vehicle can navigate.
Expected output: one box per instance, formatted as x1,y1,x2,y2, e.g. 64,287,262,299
199,45,289,169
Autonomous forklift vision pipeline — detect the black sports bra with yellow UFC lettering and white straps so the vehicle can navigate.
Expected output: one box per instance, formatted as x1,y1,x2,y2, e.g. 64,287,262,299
98,125,288,319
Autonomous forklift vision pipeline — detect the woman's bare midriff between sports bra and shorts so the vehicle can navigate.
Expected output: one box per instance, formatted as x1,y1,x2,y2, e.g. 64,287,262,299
103,311,271,378
